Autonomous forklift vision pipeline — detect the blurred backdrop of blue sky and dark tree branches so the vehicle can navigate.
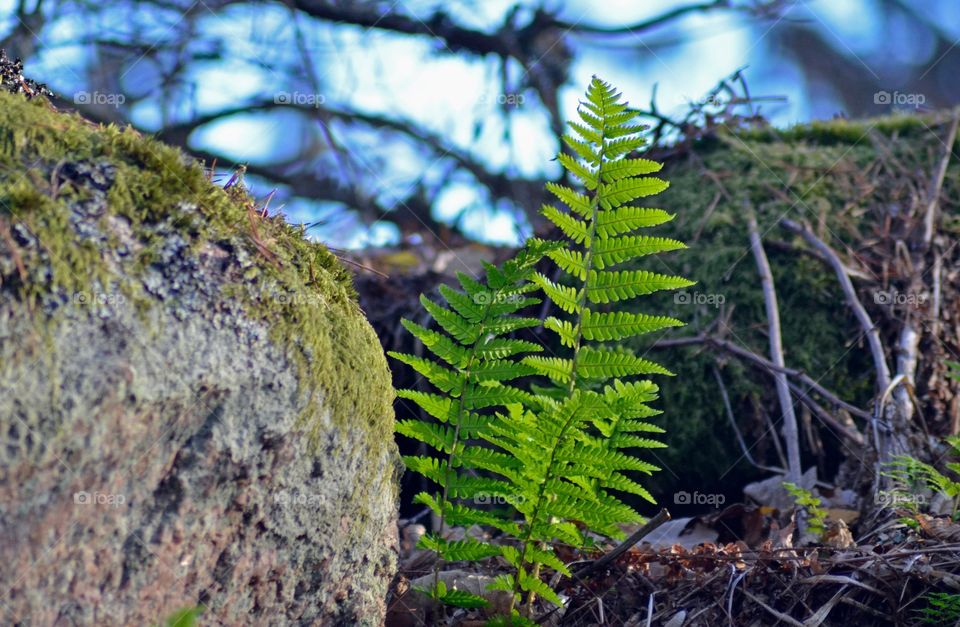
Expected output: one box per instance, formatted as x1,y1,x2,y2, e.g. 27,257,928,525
0,0,960,248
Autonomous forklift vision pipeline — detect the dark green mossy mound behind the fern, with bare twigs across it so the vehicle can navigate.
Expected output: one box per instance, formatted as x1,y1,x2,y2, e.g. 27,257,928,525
638,112,960,512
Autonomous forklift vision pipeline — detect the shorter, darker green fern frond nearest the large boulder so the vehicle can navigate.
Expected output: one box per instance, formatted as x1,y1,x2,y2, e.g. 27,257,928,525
390,242,556,607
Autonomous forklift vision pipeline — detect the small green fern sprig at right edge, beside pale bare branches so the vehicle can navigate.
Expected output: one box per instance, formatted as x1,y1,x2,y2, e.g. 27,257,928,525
881,435,960,518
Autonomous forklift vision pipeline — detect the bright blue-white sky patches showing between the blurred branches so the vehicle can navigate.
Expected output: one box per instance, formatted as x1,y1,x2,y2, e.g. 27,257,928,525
0,0,947,247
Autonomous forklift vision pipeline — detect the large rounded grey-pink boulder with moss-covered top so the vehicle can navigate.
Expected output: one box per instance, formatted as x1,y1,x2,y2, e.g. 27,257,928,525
0,84,400,625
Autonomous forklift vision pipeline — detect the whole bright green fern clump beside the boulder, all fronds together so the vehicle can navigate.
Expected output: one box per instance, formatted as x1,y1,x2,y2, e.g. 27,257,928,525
393,78,692,623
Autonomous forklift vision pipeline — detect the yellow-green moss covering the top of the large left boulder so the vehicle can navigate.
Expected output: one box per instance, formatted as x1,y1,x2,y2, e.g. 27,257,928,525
0,93,393,450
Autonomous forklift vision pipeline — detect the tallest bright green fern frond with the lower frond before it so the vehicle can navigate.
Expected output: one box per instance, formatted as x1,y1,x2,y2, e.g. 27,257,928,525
480,78,692,610
